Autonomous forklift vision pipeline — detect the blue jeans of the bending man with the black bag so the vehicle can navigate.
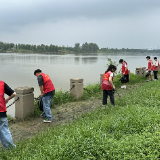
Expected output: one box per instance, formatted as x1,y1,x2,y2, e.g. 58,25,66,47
42,95,54,121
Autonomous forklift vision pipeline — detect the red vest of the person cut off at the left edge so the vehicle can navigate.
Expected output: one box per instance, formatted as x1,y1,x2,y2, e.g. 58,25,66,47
0,81,7,112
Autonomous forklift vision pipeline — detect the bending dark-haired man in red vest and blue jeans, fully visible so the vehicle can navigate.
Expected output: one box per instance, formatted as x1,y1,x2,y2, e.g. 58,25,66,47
34,69,55,123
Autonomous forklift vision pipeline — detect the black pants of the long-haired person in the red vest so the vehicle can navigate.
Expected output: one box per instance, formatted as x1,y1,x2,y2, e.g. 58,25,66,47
103,90,114,105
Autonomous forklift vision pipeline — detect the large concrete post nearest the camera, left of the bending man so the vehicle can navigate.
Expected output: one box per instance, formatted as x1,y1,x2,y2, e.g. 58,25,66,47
15,87,34,120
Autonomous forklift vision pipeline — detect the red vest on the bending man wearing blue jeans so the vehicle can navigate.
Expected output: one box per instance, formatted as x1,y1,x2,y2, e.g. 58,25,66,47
40,73,55,94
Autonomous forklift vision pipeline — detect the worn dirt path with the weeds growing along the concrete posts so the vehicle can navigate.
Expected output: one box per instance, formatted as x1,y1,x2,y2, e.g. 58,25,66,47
5,74,144,142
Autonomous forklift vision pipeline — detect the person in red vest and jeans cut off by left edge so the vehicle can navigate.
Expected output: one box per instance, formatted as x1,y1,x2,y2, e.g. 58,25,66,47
0,81,16,149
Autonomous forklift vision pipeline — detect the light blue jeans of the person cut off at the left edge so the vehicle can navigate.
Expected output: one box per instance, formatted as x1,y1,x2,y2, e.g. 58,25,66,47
0,117,15,149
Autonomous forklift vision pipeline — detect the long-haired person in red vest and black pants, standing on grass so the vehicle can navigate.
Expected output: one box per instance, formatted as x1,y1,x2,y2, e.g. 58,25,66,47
102,65,117,107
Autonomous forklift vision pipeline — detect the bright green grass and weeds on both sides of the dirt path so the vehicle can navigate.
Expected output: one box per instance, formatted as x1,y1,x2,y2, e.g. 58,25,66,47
0,74,160,160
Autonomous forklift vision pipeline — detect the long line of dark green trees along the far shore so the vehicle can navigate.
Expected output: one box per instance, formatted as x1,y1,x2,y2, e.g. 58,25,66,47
0,41,160,53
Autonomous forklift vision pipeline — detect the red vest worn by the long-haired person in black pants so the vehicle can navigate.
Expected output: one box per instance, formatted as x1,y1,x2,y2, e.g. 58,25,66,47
102,71,113,90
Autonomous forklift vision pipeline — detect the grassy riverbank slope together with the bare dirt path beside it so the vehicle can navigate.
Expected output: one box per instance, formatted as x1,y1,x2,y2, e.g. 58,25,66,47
1,76,160,160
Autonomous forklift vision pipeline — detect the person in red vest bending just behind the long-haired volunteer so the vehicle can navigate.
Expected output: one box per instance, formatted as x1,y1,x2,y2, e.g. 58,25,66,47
119,59,129,89
